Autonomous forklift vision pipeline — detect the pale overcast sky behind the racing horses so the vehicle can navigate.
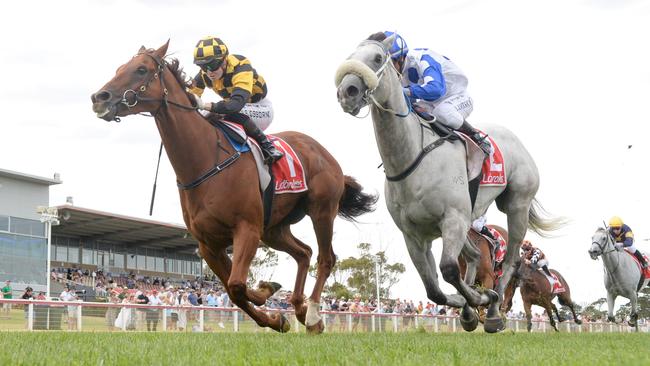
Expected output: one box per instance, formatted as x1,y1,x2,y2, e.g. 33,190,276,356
0,0,650,312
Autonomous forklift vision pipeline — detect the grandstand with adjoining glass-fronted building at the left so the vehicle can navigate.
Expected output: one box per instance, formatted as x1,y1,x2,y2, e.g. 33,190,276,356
0,169,202,296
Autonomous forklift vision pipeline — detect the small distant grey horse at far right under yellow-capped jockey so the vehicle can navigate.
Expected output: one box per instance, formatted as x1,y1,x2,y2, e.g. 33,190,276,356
589,228,648,331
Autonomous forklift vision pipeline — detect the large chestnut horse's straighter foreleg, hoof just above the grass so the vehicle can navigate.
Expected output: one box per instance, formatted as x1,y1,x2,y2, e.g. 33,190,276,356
228,222,291,333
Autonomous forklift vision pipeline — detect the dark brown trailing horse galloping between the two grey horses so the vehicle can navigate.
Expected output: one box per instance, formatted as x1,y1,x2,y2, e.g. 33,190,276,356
503,260,582,332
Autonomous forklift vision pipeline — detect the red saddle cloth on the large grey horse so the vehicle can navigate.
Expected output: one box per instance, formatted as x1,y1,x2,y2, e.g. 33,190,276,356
456,131,508,187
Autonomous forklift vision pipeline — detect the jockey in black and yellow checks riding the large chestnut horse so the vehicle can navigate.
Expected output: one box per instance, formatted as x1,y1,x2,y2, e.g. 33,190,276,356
190,36,283,163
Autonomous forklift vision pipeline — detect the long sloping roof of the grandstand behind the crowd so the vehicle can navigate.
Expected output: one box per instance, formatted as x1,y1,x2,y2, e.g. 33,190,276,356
52,205,197,254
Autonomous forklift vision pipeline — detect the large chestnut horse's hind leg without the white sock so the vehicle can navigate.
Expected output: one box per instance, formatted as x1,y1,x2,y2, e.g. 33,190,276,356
263,225,312,324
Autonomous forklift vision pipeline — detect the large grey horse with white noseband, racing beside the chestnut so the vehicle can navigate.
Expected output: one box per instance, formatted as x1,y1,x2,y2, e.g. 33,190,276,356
336,37,563,333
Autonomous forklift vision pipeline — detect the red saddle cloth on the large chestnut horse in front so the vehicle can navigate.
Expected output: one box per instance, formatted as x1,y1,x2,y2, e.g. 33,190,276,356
223,121,308,194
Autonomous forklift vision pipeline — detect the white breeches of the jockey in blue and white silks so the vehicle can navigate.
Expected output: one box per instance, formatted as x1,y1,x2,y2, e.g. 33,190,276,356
415,93,474,130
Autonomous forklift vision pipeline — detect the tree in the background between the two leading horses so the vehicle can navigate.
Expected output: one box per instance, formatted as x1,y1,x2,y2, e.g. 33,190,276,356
310,243,406,299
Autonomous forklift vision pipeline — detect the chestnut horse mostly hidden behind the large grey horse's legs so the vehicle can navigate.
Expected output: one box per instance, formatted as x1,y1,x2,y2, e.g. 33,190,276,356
458,225,508,322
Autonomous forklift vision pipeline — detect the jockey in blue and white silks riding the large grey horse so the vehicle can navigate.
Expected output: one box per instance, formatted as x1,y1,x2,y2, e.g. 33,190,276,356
369,31,491,155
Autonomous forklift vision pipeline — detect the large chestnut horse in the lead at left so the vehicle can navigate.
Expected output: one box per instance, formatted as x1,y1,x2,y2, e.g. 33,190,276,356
91,41,377,333
